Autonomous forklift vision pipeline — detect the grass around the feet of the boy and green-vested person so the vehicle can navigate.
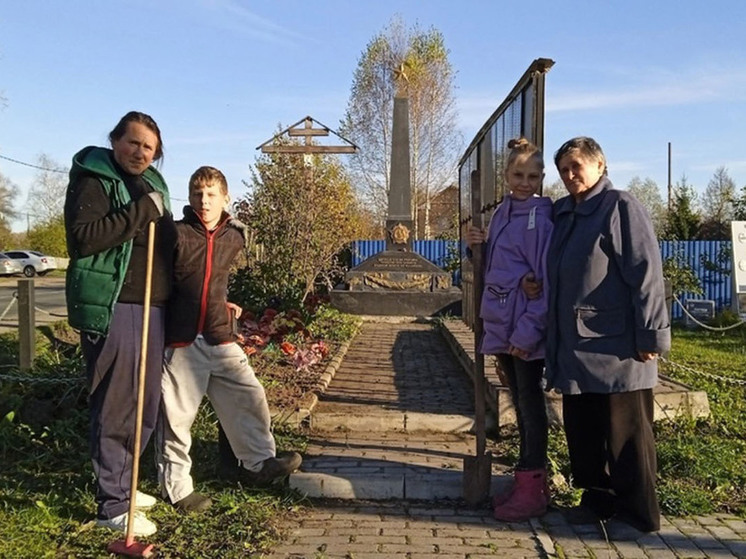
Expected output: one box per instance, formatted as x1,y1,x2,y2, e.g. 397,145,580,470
0,320,334,558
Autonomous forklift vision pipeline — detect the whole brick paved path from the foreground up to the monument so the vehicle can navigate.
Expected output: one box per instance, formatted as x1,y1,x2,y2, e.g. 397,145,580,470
264,323,746,559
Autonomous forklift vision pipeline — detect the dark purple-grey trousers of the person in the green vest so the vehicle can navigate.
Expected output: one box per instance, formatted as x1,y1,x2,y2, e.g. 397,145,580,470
81,303,165,518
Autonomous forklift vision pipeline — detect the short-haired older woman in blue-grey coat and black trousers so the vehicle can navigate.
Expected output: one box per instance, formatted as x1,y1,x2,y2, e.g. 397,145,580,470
546,137,671,532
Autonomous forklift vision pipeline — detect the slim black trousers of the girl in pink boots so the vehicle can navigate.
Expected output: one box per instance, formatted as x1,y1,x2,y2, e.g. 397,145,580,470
497,353,548,470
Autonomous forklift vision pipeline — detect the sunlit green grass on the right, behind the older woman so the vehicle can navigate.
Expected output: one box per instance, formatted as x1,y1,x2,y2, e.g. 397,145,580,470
488,326,746,518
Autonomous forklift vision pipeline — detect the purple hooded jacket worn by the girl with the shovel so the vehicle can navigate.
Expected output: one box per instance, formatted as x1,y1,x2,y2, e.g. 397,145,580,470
479,195,552,360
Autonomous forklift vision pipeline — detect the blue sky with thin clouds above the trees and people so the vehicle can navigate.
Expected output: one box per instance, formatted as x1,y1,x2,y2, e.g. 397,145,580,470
0,0,746,228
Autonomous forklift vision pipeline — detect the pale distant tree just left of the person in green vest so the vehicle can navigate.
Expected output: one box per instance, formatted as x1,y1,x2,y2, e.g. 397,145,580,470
26,153,68,224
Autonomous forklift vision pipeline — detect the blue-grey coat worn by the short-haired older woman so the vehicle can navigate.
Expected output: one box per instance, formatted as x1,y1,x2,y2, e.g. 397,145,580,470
546,177,671,394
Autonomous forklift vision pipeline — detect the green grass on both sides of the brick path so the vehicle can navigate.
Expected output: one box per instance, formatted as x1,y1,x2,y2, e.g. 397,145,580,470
0,318,746,558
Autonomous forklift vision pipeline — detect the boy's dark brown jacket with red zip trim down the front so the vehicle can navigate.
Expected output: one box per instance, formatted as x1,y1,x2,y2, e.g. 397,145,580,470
166,206,246,346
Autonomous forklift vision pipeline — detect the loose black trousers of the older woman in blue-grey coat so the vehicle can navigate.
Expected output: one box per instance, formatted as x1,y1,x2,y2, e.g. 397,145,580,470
562,389,660,532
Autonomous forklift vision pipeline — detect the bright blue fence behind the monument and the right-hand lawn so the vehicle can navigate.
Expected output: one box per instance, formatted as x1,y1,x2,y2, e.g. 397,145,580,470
352,240,732,318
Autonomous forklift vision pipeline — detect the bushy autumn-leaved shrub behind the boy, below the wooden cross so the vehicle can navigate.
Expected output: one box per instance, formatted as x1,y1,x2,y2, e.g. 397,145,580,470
234,138,370,306
